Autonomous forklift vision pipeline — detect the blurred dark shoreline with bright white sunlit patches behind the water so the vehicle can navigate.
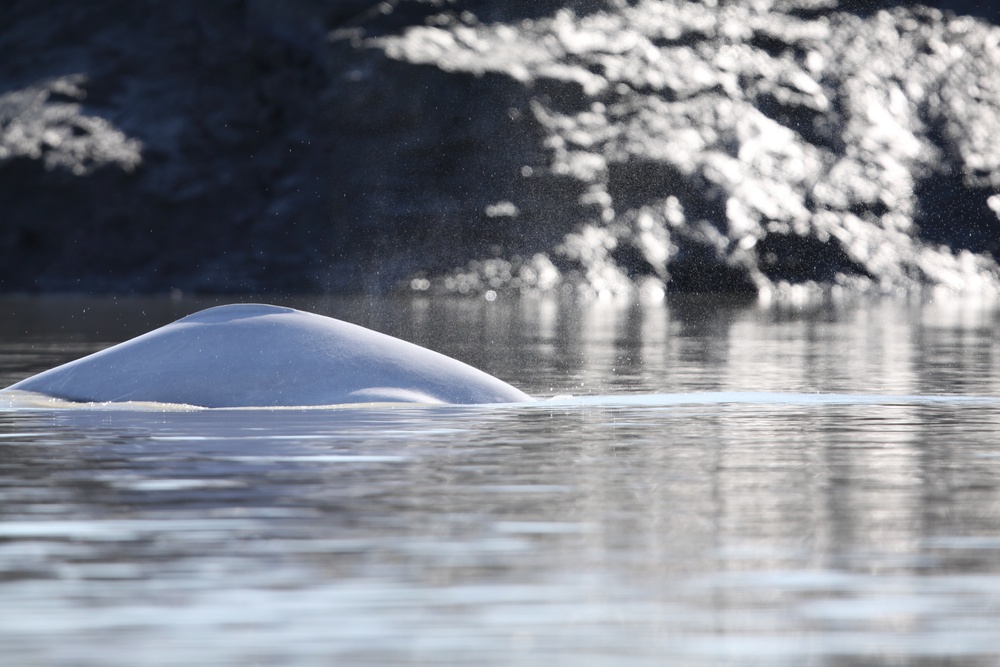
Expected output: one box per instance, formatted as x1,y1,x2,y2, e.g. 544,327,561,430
0,0,1000,294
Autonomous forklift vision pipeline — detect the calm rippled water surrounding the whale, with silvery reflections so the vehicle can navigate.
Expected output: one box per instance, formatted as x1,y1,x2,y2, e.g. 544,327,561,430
0,298,1000,666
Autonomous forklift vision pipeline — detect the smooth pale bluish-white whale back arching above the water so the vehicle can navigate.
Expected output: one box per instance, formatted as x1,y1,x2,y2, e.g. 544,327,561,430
7,304,532,408
